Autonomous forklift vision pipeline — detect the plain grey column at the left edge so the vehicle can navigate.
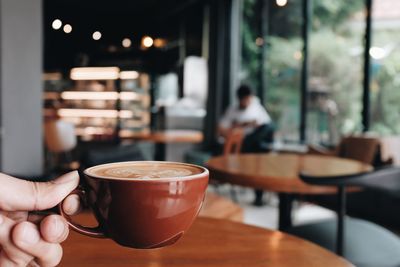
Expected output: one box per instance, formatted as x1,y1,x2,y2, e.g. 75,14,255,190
0,0,43,177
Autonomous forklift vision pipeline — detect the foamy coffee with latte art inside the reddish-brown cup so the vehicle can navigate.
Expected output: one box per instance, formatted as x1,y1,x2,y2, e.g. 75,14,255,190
88,162,203,179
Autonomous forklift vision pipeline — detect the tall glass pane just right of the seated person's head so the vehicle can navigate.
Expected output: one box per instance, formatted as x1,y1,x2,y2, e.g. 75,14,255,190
264,0,303,142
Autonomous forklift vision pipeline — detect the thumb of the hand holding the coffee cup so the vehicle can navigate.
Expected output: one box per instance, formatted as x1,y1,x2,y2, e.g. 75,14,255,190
0,171,79,211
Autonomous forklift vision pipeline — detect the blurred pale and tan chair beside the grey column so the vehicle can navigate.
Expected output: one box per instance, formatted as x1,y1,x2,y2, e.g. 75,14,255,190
44,120,79,174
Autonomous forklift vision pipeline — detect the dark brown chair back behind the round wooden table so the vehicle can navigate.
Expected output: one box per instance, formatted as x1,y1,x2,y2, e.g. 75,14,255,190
309,136,379,165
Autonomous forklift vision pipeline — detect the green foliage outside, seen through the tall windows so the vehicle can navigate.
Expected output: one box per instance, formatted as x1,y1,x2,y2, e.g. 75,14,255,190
242,0,400,142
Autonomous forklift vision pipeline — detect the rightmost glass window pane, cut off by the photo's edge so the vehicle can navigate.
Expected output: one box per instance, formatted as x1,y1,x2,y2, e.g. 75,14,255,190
369,0,400,134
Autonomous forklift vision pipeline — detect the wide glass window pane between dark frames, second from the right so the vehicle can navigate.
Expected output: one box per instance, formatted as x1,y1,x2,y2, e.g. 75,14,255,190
307,0,365,145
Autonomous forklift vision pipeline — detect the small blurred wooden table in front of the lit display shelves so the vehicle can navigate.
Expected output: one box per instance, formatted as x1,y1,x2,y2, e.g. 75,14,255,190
120,130,203,161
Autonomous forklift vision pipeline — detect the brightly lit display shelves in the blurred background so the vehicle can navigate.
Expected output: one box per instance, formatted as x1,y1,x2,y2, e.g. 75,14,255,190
44,67,150,141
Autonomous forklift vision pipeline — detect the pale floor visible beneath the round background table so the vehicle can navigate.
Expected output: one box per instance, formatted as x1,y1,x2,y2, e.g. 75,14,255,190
210,185,335,229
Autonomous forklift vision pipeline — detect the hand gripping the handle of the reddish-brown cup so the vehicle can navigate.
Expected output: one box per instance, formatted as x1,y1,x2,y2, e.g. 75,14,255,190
0,171,79,267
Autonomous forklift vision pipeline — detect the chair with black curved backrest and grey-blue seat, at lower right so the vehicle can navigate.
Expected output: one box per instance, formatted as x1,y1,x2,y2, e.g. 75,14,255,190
288,167,400,267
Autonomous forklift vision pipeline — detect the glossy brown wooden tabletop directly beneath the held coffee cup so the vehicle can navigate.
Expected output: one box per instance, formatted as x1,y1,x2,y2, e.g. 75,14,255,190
60,217,353,267
